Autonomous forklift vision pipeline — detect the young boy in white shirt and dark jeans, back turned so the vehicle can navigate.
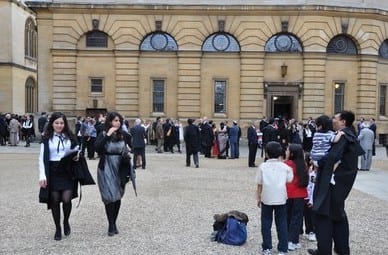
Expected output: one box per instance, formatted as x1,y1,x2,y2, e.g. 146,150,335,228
255,142,294,255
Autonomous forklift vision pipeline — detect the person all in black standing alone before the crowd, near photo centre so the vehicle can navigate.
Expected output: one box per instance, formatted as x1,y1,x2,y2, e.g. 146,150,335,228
184,119,201,168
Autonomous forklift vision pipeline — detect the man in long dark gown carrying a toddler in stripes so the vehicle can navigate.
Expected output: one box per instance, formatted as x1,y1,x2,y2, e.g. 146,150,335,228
308,111,363,255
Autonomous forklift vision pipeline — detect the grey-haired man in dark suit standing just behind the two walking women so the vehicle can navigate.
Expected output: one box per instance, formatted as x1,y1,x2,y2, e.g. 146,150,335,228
130,119,146,169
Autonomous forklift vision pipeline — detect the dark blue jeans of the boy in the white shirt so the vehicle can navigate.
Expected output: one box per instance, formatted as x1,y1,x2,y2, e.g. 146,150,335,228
261,203,288,253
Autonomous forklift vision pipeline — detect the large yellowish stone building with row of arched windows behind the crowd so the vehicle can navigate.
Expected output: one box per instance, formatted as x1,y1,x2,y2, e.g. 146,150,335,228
27,0,388,137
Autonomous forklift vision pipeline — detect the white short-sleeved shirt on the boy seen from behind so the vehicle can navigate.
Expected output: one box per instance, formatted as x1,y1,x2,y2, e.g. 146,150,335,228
255,159,294,205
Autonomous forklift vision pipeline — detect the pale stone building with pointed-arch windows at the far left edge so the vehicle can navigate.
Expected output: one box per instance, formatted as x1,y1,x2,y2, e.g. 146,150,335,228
0,0,38,114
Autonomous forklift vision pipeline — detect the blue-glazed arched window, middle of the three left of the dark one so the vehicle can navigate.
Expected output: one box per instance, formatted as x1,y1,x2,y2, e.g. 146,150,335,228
202,32,240,52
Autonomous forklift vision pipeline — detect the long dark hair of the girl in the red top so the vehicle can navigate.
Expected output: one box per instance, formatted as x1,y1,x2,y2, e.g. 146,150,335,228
288,143,309,187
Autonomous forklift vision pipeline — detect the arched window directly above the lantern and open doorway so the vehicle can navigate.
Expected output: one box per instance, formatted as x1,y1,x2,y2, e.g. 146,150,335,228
264,33,303,52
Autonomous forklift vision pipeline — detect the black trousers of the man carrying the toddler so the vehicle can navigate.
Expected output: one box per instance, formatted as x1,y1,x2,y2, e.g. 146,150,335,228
314,214,350,255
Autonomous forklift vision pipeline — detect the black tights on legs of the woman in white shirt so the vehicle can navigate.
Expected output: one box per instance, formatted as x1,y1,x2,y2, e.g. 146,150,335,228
50,190,73,230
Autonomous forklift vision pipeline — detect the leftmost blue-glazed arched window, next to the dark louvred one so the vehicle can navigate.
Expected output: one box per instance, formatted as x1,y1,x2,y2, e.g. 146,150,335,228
140,32,178,51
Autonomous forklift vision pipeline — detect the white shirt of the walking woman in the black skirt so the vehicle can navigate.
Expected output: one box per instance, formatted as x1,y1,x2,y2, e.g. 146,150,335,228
39,135,78,181
